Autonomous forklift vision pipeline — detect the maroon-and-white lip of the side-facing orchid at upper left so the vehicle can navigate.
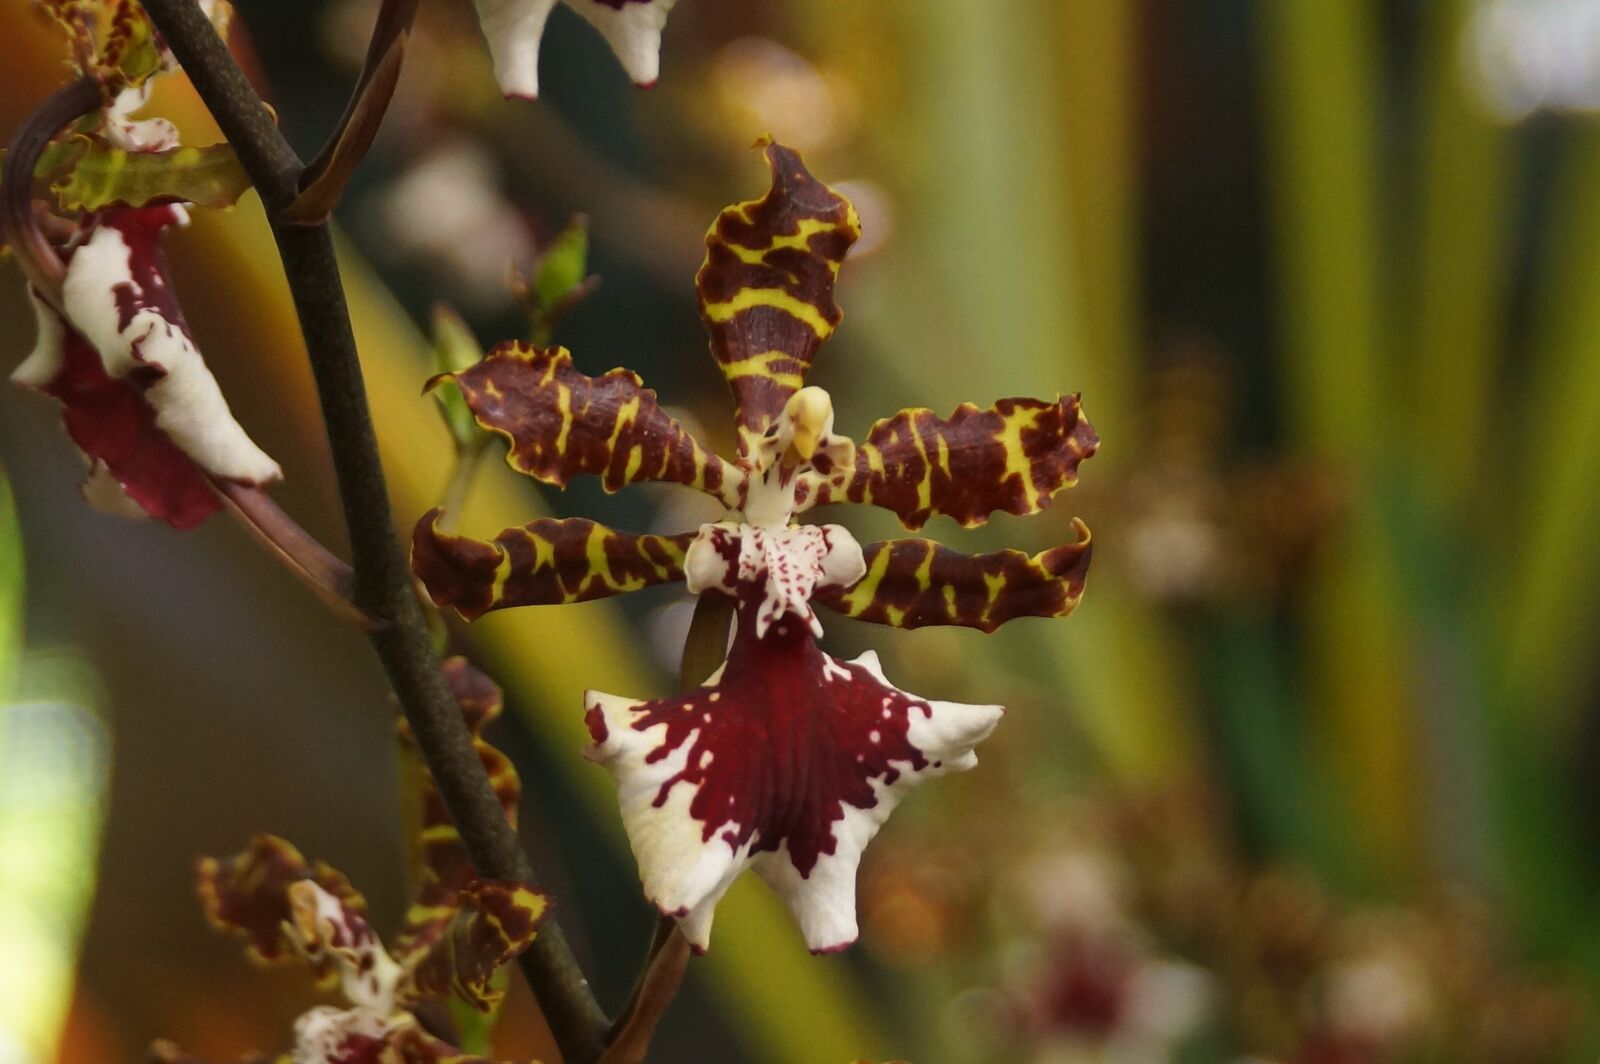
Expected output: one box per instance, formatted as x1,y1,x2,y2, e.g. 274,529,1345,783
13,205,282,528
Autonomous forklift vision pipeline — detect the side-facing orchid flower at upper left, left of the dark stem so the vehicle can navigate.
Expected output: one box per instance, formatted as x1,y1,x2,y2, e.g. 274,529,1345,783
11,0,282,528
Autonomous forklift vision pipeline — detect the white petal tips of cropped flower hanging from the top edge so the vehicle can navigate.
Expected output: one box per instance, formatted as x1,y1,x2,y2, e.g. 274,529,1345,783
474,0,677,99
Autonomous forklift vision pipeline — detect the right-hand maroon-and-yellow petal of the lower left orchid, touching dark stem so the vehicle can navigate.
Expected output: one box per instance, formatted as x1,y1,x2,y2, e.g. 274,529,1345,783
402,880,549,1013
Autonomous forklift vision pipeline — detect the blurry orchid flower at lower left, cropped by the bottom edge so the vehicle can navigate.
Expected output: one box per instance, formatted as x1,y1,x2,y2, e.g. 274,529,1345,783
154,658,546,1064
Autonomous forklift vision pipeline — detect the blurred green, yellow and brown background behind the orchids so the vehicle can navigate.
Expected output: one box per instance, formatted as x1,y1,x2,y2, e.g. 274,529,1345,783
0,0,1600,1064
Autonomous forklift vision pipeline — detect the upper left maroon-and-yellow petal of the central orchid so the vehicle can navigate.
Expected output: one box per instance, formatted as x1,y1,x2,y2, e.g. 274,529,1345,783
435,342,742,506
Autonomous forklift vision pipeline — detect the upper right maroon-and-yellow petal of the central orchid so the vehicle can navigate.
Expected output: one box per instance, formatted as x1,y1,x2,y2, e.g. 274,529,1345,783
808,395,1099,530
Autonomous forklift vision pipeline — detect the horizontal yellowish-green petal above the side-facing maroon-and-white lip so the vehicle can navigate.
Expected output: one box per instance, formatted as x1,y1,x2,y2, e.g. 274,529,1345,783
51,138,250,211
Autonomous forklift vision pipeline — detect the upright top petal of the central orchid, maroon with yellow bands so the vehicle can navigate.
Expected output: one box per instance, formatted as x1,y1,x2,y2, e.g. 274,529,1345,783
694,142,861,454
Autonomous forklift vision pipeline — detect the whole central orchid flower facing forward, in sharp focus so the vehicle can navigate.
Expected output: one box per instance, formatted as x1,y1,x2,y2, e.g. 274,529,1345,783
413,144,1098,952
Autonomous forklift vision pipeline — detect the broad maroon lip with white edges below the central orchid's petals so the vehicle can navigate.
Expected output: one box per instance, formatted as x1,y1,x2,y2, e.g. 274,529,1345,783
586,605,1002,952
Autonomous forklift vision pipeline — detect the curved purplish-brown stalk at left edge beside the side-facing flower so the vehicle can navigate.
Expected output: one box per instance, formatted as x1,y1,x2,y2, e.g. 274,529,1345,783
0,77,101,310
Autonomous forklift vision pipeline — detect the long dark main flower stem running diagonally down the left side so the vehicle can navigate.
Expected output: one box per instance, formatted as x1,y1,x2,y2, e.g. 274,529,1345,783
144,0,610,1064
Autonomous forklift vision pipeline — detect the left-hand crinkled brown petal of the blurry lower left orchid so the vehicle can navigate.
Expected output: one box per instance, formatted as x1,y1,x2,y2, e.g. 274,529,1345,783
198,835,366,978
